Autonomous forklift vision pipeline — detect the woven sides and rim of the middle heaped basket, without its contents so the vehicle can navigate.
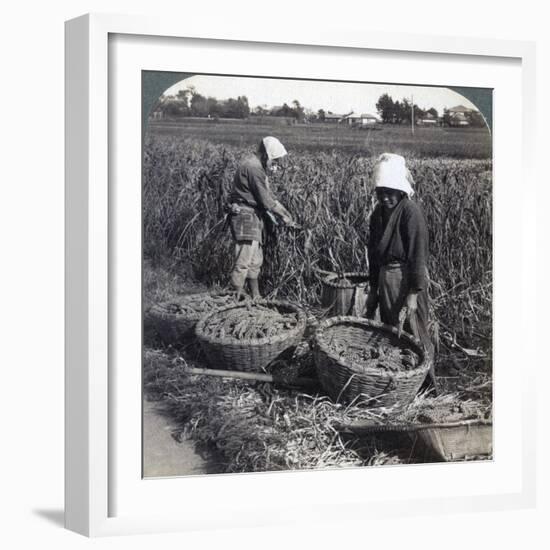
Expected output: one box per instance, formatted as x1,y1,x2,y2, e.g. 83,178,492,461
195,300,306,372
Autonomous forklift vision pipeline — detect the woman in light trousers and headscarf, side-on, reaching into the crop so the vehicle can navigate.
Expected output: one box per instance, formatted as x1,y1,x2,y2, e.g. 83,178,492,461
229,136,294,299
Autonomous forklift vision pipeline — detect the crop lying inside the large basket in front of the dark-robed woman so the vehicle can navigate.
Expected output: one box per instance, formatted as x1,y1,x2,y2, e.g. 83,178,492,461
330,341,420,372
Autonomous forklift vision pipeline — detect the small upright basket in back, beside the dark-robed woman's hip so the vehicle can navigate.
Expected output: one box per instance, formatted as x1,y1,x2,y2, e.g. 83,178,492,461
321,272,369,316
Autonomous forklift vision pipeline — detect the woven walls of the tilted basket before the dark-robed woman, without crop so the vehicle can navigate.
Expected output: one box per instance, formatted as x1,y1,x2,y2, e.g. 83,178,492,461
313,317,430,407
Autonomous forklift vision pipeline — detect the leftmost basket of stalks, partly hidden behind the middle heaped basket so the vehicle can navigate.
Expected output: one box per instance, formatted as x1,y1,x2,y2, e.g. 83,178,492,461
144,292,235,345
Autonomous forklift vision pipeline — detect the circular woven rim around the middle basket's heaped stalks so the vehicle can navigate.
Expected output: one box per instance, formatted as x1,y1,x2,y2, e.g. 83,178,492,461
195,300,307,347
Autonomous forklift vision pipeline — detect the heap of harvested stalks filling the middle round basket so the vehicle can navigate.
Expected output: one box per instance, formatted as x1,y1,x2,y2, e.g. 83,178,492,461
204,303,298,340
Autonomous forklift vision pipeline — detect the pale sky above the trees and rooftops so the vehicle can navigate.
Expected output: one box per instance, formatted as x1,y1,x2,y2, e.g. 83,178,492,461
165,75,484,114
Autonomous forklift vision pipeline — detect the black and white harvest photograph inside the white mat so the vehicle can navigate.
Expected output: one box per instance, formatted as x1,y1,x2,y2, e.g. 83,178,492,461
142,71,493,478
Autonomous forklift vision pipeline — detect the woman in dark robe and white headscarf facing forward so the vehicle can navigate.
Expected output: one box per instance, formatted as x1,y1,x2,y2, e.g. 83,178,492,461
367,153,435,385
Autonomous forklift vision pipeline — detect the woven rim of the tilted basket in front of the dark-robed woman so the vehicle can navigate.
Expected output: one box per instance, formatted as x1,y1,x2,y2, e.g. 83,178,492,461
313,315,430,379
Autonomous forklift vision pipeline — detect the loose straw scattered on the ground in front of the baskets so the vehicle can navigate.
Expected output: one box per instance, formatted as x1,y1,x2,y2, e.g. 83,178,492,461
144,351,492,472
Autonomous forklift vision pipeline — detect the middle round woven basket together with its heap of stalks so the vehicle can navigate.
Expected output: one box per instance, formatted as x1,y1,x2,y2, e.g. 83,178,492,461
195,300,306,372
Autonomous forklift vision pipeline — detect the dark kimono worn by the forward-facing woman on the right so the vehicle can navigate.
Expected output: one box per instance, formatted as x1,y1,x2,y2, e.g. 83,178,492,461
368,197,433,355
